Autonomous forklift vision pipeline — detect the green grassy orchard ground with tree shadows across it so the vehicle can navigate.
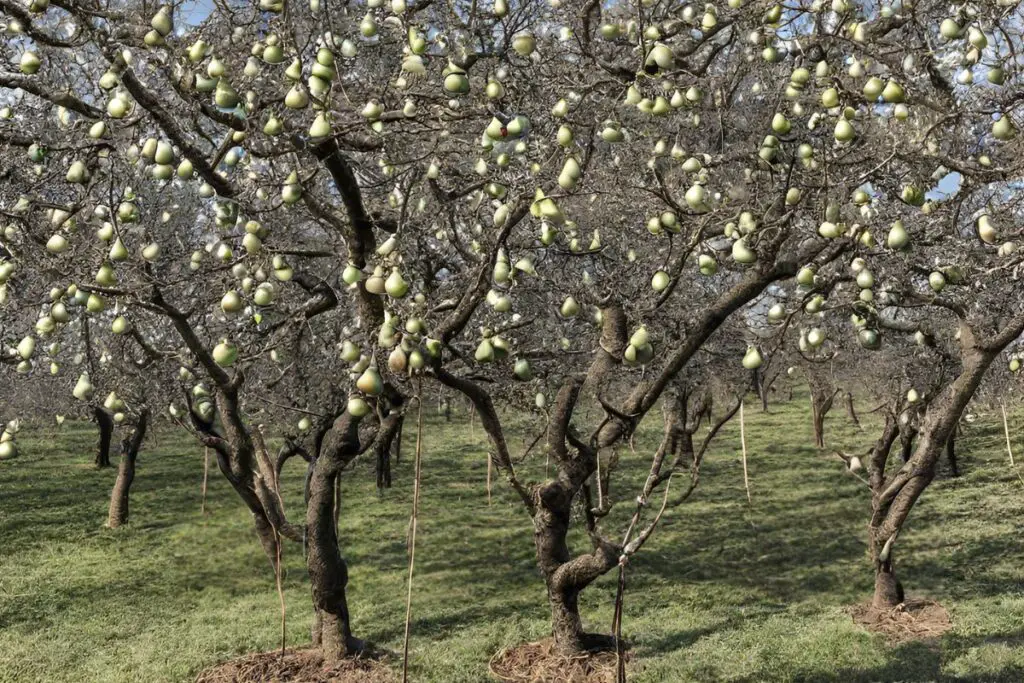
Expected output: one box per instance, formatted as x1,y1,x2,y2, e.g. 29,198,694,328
0,400,1024,683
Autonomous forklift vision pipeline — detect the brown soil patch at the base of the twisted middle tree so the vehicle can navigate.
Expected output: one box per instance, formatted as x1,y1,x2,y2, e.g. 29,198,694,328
490,638,630,683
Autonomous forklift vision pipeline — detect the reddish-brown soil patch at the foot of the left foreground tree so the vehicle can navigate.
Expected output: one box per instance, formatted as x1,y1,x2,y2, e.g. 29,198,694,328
196,649,397,683
